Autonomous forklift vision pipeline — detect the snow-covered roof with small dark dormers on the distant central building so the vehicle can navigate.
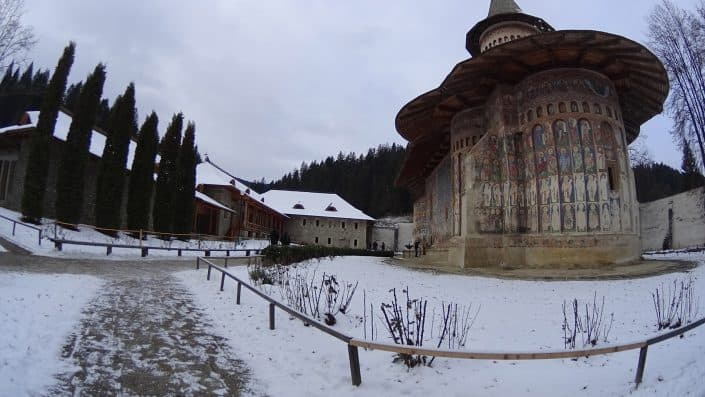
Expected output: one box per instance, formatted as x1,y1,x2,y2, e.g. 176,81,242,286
263,190,374,221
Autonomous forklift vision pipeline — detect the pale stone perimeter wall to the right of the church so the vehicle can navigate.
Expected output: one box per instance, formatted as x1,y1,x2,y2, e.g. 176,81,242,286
639,187,705,251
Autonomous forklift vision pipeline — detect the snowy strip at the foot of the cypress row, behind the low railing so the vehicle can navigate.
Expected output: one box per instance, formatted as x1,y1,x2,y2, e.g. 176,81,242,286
0,207,269,260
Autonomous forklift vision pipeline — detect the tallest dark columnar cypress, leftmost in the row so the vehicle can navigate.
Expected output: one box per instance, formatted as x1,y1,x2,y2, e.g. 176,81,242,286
22,42,75,223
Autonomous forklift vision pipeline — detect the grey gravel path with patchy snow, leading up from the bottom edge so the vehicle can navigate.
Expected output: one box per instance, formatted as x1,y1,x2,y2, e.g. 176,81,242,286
0,242,251,396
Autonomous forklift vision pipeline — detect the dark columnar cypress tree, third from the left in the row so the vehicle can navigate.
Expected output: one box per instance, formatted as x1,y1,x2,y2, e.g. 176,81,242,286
95,83,137,229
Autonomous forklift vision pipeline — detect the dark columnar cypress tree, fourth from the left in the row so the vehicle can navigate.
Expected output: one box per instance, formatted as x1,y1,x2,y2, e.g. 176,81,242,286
127,112,159,230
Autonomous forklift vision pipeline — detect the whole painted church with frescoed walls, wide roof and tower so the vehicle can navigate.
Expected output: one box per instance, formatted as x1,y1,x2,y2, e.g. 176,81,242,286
396,0,669,267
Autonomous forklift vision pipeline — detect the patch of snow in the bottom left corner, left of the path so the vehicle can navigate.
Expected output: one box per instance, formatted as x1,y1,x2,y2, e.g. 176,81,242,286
0,273,102,396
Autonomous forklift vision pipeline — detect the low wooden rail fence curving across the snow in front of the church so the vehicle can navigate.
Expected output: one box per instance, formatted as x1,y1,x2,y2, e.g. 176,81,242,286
196,257,705,387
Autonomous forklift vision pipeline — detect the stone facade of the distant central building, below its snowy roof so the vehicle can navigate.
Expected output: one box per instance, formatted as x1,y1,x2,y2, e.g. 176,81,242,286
284,215,367,248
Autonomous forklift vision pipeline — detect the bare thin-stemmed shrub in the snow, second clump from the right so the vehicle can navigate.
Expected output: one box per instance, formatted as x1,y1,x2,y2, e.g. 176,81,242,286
561,292,614,349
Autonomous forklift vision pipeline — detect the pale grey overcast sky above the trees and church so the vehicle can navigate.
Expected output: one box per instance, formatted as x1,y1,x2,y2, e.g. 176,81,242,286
25,0,695,180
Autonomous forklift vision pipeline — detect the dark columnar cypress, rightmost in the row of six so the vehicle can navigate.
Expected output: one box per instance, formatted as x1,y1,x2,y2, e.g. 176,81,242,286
173,122,197,234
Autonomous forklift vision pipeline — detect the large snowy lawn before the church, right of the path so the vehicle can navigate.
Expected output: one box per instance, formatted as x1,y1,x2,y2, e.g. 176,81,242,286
177,253,705,396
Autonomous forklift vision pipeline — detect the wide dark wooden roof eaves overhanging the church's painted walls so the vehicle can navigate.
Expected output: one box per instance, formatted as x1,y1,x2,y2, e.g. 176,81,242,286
396,30,669,186
